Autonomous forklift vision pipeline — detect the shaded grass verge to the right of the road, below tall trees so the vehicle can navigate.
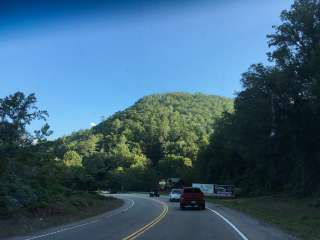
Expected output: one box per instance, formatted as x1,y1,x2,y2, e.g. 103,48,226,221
207,196,320,240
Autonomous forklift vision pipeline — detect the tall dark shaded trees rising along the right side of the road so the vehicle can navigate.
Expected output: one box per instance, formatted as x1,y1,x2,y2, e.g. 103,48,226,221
199,0,320,195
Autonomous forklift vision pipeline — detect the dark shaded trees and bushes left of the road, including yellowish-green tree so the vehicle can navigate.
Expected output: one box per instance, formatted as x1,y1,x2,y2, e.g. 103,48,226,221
0,92,101,216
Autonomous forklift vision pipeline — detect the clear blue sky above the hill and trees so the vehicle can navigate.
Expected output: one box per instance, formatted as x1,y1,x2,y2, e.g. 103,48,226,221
0,0,292,137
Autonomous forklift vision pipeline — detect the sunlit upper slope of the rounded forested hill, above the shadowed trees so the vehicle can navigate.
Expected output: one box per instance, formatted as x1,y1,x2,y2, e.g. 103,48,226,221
93,93,233,165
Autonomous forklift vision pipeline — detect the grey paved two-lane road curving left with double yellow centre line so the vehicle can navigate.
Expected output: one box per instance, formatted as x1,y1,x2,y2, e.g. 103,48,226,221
7,194,293,240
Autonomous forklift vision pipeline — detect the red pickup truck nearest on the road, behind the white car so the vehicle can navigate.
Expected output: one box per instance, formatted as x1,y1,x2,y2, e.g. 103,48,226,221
180,187,206,210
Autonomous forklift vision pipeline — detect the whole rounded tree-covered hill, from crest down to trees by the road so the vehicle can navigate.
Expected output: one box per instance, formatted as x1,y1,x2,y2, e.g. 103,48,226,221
58,93,233,189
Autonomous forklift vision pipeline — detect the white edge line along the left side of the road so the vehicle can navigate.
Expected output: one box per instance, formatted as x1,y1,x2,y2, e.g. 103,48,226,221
24,199,135,240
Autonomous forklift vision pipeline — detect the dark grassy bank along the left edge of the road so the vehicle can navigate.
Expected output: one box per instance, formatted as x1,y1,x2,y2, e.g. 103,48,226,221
0,193,123,238
